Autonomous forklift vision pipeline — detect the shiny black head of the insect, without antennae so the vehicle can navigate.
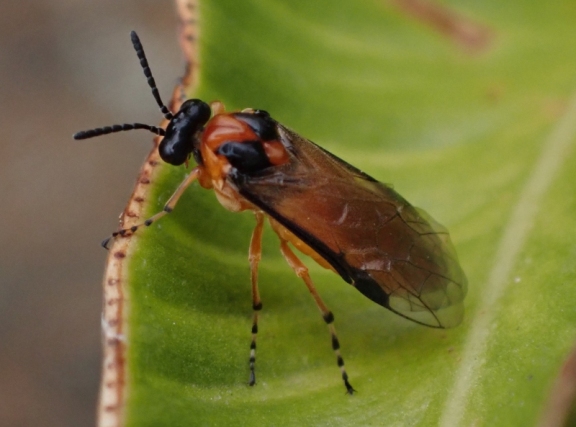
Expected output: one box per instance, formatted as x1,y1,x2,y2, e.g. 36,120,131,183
158,99,211,166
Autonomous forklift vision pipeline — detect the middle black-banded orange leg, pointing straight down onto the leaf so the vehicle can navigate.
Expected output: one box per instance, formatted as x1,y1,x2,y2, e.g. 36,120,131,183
248,212,264,386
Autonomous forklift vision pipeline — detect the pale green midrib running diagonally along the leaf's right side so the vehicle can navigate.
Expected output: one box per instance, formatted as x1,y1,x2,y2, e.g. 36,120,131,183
439,88,576,426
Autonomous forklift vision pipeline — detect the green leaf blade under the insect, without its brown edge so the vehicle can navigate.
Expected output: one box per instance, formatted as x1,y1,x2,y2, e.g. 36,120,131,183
110,0,576,426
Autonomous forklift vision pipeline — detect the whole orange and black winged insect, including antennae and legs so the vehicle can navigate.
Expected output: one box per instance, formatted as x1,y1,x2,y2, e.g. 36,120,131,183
74,32,467,394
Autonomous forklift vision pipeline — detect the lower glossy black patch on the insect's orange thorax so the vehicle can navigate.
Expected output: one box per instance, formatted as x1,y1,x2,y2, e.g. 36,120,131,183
216,141,272,174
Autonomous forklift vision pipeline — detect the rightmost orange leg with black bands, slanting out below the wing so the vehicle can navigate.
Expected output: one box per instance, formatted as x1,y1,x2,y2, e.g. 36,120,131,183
280,240,356,394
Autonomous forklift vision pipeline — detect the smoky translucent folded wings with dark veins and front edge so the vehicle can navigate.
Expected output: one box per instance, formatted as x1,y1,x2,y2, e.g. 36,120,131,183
229,125,467,328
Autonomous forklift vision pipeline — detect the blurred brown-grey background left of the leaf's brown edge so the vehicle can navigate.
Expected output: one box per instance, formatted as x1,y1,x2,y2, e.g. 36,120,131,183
0,0,184,427
